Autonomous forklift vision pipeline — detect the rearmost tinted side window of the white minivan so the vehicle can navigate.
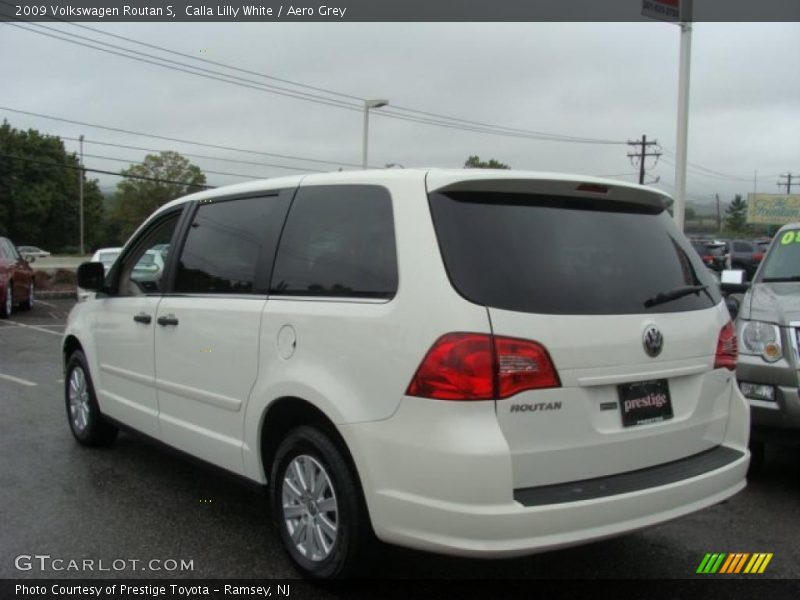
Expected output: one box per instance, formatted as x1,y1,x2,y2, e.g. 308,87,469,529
271,185,397,298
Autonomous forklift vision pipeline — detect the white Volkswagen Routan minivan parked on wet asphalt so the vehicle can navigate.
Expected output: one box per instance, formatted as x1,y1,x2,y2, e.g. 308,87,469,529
63,170,749,577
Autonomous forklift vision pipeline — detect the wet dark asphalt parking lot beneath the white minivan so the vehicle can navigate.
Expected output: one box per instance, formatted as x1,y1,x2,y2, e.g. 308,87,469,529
0,300,800,580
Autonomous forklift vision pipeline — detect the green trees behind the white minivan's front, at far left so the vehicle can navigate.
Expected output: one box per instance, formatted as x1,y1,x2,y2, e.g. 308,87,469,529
0,121,206,253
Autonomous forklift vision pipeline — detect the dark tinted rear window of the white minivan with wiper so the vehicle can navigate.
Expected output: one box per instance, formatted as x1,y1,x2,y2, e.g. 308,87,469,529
430,192,721,314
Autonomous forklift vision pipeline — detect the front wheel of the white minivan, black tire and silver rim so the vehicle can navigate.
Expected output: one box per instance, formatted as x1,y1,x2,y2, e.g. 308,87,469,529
64,350,119,446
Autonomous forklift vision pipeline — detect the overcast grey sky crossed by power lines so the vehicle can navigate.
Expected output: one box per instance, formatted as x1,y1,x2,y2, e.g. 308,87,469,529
0,22,800,202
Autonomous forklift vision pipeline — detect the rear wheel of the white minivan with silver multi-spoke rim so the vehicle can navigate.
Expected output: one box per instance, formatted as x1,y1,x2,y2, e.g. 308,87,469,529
270,426,374,579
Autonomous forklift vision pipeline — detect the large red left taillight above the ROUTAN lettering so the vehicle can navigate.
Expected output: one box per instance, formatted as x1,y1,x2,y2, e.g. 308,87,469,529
406,333,561,400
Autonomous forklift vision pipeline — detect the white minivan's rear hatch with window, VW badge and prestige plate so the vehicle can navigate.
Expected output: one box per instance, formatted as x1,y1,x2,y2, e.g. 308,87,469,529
428,173,731,488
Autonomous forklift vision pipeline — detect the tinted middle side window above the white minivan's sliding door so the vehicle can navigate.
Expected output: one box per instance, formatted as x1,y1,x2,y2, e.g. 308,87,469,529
174,190,292,294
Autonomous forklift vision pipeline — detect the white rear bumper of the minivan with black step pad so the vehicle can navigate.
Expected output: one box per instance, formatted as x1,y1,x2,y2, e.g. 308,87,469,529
341,393,750,558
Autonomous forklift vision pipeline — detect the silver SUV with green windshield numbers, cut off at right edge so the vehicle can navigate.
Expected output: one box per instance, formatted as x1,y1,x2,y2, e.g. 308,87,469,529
736,223,800,459
